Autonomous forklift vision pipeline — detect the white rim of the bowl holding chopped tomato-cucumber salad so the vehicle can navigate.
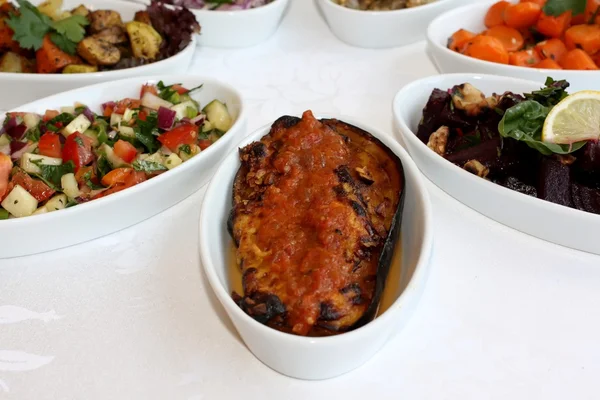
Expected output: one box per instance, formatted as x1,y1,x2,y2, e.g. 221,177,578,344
0,75,247,230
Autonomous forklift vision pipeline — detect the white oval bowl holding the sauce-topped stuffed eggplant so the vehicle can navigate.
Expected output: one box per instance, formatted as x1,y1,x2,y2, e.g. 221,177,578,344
200,117,433,379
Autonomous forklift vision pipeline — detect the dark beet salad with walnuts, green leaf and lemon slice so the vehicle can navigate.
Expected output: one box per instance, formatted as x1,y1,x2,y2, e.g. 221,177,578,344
417,79,600,214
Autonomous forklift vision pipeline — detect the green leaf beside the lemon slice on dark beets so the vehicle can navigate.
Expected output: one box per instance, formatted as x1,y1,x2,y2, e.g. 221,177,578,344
498,100,586,155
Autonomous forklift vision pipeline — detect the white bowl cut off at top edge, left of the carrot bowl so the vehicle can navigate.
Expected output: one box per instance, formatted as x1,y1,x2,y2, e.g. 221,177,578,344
318,0,462,49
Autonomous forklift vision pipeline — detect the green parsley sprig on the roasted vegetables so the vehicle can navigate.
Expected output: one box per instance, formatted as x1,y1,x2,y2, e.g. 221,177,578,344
7,0,52,50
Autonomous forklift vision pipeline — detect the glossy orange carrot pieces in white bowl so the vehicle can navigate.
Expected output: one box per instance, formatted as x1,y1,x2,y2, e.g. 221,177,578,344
448,0,600,70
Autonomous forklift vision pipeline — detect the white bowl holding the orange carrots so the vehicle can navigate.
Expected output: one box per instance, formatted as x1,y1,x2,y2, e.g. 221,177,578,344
427,1,600,91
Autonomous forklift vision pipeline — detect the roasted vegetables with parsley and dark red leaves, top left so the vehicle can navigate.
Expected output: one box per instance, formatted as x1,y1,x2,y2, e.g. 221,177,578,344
0,0,200,74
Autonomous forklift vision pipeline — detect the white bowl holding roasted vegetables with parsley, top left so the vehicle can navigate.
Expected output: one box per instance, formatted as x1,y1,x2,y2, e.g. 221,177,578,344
0,0,196,110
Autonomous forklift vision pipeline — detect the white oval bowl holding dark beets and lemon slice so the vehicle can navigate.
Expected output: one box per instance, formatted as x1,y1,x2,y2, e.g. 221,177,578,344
393,74,600,254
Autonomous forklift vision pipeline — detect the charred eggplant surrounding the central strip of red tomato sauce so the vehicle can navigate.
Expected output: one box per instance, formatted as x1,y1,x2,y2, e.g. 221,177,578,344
227,113,405,336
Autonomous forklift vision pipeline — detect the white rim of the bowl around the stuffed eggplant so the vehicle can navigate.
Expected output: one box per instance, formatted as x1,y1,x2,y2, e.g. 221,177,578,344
198,112,434,346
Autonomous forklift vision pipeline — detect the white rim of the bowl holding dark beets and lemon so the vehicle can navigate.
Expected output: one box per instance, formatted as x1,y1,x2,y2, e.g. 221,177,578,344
392,73,600,225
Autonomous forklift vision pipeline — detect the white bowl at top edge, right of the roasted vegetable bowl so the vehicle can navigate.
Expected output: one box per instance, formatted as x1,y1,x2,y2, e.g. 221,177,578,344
190,0,289,48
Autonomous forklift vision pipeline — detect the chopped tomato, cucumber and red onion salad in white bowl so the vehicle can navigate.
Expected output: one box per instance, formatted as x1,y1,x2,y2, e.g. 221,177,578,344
0,82,233,219
